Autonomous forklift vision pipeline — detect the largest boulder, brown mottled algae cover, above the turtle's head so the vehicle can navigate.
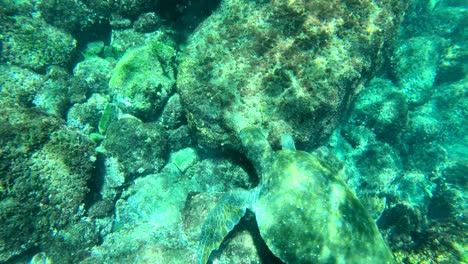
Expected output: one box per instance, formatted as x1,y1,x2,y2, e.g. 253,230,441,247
177,0,407,150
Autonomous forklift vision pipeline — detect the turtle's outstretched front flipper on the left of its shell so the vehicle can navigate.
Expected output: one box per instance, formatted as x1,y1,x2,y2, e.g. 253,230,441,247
198,189,252,264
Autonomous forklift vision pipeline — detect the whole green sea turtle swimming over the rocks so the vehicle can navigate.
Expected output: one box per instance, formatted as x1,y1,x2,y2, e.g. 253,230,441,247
198,128,394,264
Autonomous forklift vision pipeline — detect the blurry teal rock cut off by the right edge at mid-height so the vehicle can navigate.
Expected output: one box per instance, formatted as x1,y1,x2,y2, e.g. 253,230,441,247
403,79,468,174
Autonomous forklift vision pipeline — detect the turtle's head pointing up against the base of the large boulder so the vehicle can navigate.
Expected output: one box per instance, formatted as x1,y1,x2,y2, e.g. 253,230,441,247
239,127,273,175
